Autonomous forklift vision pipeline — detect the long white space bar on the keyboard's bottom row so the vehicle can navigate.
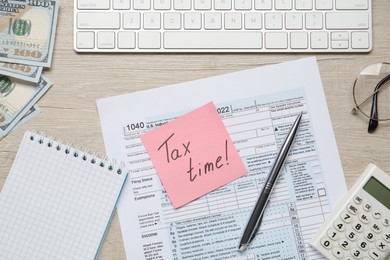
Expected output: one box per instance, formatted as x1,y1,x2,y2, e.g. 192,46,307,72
164,31,262,49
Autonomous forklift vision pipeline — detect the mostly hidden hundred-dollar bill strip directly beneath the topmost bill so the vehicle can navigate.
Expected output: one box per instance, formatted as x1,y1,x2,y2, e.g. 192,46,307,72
0,61,43,83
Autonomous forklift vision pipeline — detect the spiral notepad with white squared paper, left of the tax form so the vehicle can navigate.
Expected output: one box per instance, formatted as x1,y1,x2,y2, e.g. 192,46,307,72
0,132,127,259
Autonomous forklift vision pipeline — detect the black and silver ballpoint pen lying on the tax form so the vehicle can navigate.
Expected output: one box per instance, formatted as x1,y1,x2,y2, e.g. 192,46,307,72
238,112,302,251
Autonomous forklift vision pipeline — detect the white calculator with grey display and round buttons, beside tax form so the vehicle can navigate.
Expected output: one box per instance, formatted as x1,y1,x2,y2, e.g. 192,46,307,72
310,164,390,260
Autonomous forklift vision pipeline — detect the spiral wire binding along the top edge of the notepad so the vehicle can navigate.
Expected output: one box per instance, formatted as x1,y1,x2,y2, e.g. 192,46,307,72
30,130,124,174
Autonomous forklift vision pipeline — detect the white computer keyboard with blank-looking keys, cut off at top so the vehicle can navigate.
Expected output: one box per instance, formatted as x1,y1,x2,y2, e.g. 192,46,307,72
74,0,372,53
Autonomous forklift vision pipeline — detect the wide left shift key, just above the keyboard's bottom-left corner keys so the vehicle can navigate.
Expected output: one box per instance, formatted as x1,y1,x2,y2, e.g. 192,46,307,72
77,12,120,29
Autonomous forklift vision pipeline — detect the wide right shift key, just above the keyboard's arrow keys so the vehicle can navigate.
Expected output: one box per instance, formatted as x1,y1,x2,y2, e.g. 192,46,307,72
325,12,368,29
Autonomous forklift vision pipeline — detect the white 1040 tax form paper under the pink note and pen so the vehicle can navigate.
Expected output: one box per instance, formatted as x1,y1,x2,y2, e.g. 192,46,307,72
97,57,347,260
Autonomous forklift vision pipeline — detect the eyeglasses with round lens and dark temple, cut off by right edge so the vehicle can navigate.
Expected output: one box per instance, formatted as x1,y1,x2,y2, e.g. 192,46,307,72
352,62,390,133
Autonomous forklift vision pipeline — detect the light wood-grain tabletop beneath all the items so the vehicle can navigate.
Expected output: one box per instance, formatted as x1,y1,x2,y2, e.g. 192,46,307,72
0,0,390,259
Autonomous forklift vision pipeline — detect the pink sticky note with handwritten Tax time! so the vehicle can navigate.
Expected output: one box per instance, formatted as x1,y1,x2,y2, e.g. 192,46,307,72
141,102,247,208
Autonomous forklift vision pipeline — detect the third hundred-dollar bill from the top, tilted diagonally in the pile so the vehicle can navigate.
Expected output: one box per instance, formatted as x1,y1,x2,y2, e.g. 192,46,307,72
0,75,52,137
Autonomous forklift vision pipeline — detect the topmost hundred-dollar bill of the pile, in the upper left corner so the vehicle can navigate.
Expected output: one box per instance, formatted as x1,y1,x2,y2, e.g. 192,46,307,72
0,0,58,67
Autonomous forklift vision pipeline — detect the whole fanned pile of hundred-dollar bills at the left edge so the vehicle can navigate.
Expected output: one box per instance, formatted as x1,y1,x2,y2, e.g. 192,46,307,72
0,0,58,139
